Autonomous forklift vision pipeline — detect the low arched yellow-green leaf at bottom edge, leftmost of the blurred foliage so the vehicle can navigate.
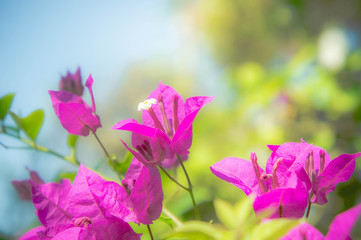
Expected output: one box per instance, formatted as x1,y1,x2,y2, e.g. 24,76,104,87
163,221,227,240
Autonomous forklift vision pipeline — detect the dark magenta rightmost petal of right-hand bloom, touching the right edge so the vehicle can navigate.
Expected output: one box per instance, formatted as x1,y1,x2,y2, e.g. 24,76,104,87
313,153,361,204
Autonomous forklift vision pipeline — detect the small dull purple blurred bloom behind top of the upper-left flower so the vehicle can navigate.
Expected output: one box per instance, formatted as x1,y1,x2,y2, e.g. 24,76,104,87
59,67,84,97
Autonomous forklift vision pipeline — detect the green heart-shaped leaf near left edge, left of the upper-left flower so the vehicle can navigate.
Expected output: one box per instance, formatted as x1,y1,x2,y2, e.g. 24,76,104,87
10,109,44,141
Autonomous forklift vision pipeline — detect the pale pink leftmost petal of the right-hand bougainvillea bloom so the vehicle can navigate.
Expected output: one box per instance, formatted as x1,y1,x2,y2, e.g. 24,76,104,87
211,157,263,195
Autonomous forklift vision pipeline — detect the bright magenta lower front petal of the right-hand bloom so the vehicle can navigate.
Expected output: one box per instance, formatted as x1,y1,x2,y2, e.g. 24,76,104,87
253,188,308,218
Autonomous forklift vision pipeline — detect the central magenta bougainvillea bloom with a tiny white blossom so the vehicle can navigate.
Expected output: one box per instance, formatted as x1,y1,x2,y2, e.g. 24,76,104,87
113,83,213,168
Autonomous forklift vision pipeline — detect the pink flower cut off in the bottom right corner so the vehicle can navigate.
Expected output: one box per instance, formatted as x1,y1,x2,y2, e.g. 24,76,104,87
280,204,361,240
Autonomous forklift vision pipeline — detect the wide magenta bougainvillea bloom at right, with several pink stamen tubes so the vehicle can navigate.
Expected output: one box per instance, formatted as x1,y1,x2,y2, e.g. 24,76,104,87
211,140,361,218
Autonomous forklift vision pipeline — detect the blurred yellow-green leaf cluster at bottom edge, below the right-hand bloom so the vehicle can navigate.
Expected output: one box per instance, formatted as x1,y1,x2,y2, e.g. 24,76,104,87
164,197,302,240
